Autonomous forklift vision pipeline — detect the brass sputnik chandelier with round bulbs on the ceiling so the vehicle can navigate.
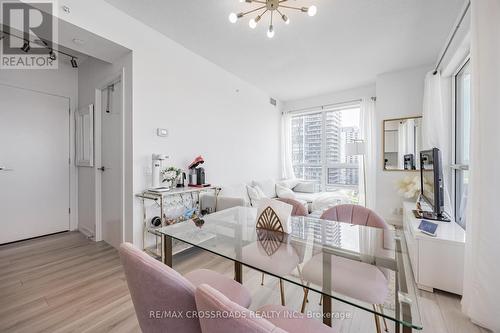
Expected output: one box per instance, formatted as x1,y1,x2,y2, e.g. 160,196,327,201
229,0,318,38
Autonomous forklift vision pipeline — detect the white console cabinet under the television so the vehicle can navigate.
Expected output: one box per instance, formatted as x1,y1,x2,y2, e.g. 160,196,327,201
403,202,465,295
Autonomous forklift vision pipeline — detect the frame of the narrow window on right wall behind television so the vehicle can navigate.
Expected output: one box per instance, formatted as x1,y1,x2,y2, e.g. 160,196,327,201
450,53,472,229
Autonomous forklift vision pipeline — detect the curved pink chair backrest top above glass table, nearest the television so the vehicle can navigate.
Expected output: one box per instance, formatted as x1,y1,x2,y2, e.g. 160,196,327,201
321,205,389,229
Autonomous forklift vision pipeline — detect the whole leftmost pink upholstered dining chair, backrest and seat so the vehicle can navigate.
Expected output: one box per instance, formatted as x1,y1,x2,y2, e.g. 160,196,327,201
120,243,251,333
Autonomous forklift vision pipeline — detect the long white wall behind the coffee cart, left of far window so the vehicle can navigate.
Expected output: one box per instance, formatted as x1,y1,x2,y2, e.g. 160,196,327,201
58,0,280,246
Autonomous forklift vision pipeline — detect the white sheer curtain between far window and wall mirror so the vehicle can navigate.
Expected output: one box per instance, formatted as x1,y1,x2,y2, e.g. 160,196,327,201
359,98,377,209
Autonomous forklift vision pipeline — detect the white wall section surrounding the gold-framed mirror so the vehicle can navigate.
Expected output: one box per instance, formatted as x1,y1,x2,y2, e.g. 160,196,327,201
375,65,432,224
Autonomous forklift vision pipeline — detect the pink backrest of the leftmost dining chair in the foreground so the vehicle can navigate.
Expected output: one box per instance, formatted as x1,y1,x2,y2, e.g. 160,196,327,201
120,243,201,333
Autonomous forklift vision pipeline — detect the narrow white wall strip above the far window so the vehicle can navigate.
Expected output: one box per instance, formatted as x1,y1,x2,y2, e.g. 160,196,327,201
283,84,376,111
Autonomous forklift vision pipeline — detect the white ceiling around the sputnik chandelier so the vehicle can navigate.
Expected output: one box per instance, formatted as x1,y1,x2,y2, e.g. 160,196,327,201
102,0,464,101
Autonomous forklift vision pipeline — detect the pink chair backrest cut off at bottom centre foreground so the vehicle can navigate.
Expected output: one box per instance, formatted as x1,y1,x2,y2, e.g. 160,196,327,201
195,284,286,333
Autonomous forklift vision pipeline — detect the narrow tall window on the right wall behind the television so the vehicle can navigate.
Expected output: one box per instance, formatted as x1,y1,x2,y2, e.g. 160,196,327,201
453,61,472,228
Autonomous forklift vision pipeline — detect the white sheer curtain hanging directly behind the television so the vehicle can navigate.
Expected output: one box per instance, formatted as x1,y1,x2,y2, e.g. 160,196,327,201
422,72,453,216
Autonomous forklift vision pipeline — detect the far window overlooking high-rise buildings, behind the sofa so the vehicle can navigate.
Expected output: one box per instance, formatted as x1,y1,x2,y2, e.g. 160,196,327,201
291,103,360,198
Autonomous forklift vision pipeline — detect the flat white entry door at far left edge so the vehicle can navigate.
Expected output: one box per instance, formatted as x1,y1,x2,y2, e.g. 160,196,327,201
0,85,70,244
